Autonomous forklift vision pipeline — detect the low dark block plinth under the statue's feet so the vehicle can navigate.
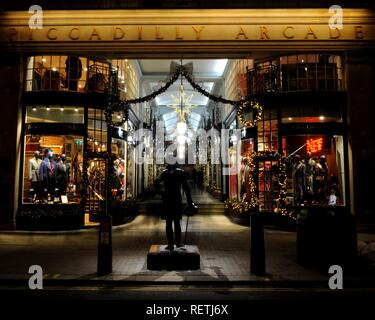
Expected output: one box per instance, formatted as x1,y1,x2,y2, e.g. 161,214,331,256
147,244,200,270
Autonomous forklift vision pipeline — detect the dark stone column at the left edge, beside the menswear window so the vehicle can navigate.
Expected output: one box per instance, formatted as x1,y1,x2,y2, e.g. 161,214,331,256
0,54,23,226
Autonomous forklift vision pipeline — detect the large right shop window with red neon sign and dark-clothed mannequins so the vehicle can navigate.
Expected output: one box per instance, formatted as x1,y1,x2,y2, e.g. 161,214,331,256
283,135,345,206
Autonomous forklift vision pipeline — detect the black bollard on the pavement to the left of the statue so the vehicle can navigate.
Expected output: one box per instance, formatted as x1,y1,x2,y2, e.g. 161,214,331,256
97,215,112,276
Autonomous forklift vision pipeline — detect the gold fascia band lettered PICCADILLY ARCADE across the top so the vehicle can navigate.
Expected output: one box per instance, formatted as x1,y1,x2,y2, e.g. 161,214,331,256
0,24,375,45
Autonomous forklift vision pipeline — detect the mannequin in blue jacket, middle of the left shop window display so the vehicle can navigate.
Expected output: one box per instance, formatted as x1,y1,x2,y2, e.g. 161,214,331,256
39,149,56,201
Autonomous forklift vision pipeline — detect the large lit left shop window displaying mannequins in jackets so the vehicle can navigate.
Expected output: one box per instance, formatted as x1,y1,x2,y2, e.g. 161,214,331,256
23,135,83,204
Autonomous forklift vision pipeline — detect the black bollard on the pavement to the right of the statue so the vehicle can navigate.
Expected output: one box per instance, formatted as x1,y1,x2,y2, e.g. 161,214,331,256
250,212,266,276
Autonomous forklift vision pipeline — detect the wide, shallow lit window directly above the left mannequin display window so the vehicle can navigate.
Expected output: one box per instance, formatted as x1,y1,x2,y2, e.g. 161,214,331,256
26,105,84,123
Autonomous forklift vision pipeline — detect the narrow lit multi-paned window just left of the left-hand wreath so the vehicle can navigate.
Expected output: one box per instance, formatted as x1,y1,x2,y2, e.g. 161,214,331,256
87,108,107,152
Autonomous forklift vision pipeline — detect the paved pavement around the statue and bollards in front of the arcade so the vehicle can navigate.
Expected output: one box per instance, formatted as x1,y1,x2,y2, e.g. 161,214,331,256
0,215,375,281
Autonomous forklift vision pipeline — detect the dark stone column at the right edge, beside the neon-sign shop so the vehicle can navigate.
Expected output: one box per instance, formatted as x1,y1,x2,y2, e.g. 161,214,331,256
345,51,375,222
